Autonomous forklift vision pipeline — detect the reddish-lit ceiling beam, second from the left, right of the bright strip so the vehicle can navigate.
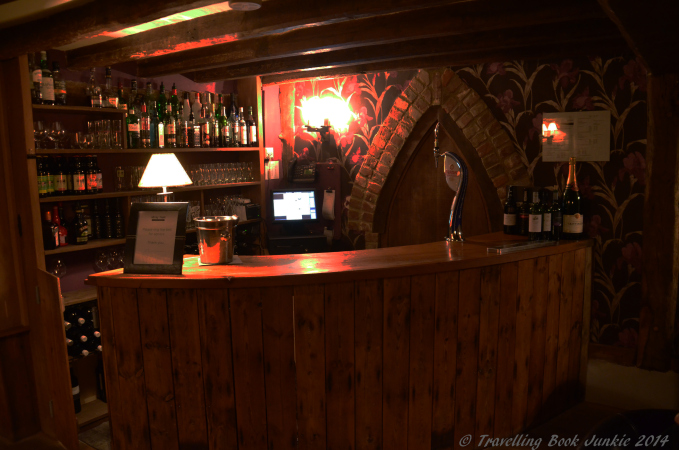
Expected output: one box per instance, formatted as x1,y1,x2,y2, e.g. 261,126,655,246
67,0,469,70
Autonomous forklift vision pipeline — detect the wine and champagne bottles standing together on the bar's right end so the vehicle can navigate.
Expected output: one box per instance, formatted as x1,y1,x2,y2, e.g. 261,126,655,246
504,158,584,241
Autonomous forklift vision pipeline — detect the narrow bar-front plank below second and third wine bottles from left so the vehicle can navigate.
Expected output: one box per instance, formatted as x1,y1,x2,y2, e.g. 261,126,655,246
512,259,535,433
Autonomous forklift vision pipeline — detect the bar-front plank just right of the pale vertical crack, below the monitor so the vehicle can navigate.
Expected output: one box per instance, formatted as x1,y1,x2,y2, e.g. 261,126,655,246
294,284,326,450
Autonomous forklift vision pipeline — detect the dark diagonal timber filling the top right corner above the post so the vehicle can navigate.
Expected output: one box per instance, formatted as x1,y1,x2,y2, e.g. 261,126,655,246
598,0,679,75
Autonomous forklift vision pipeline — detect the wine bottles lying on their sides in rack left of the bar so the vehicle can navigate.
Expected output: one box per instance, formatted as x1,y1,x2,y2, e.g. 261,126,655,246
64,304,101,358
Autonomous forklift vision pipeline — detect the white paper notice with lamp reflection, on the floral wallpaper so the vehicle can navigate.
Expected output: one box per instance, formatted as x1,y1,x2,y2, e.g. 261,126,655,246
542,111,611,162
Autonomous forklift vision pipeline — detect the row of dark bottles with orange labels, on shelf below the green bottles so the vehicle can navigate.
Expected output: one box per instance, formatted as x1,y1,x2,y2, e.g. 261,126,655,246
36,155,104,197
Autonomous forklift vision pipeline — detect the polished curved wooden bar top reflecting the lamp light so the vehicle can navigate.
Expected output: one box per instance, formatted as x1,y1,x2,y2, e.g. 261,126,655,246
86,233,592,289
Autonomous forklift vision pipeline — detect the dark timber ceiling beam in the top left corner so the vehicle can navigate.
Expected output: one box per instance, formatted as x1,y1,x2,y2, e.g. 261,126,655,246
0,0,215,60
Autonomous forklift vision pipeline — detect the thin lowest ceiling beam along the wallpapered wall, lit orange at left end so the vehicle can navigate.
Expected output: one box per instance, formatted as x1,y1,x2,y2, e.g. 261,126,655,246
262,37,628,86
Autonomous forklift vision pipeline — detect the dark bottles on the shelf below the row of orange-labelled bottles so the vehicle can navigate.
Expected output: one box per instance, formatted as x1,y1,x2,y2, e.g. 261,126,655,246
42,199,125,250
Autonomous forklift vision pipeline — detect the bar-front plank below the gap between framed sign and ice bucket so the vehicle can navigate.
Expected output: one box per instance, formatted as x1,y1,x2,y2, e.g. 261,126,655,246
167,289,208,448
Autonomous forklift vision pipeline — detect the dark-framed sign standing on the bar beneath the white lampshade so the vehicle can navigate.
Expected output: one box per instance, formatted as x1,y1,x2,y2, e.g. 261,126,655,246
123,202,188,275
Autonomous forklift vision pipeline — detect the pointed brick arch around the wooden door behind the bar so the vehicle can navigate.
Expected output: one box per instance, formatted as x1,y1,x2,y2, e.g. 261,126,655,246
348,69,530,248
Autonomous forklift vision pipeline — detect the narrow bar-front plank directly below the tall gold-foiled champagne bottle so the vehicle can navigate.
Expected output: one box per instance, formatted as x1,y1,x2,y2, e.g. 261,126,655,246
555,252,575,405
